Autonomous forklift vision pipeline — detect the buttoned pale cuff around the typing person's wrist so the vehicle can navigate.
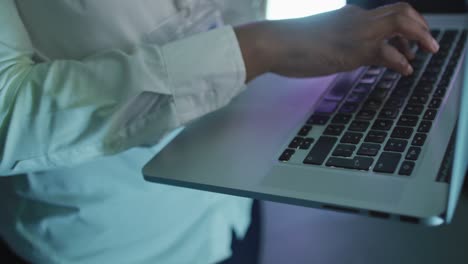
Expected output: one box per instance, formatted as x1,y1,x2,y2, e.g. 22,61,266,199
162,26,246,124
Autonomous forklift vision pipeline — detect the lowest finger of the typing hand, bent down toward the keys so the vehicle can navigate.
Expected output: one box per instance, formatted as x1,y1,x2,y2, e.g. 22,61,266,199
374,44,414,75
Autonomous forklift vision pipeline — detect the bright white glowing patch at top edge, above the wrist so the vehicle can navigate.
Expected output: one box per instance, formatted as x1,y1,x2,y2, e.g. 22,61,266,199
267,0,346,19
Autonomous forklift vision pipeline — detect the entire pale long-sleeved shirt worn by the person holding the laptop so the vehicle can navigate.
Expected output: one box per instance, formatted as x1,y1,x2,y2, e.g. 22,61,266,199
0,0,264,264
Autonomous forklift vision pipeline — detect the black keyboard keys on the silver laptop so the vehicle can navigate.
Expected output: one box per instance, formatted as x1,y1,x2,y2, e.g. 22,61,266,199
279,30,467,176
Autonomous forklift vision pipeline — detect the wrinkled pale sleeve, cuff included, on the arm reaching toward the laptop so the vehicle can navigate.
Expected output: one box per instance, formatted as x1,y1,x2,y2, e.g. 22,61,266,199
0,0,245,175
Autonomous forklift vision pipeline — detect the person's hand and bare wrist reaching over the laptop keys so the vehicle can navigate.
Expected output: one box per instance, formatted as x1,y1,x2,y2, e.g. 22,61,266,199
235,3,439,81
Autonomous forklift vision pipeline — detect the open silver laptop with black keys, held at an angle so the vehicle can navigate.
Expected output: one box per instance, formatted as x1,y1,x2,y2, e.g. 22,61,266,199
143,15,468,226
